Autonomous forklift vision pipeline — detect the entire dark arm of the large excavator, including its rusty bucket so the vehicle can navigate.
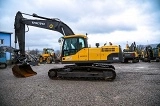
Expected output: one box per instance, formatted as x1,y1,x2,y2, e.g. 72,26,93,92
12,11,74,77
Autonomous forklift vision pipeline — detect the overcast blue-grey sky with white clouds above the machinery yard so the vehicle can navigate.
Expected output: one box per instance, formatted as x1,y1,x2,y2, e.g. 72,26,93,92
0,0,160,50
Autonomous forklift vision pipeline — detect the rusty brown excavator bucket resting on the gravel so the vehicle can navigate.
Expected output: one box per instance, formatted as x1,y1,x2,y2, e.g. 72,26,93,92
12,64,37,78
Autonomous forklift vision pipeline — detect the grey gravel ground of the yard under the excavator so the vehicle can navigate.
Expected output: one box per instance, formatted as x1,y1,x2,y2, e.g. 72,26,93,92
0,62,160,106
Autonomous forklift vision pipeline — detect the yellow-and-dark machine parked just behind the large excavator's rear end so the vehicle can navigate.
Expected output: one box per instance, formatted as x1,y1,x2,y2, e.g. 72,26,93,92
123,42,140,63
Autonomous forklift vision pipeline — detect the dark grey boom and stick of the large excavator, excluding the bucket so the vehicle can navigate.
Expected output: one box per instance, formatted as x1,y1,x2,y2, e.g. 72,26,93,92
14,11,74,55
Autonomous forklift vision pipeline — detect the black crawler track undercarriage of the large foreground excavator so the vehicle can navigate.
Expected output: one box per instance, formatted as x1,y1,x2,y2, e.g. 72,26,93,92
48,64,116,81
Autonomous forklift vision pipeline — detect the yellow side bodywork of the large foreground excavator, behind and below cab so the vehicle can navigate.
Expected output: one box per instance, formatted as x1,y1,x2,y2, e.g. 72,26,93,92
62,45,120,61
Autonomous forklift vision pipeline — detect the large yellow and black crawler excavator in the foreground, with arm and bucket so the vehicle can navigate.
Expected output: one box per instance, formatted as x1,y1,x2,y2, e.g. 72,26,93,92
12,12,123,80
